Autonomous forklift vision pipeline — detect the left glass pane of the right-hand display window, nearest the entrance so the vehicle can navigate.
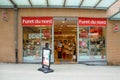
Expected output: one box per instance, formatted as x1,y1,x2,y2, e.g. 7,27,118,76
79,27,90,59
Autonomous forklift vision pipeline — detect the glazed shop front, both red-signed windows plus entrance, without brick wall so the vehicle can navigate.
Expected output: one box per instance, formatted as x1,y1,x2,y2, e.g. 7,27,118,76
21,17,107,63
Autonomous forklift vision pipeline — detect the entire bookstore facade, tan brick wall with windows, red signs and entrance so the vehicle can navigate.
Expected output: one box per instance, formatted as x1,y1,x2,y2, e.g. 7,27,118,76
0,8,120,65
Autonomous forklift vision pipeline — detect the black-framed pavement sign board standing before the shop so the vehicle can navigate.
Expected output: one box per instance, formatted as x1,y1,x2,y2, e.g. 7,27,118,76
38,48,53,73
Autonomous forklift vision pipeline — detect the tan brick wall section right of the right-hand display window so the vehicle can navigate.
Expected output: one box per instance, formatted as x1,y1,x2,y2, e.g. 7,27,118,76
106,21,120,65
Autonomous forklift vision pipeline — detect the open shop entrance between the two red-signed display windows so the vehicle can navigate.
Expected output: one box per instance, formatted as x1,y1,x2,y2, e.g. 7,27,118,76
54,18,77,63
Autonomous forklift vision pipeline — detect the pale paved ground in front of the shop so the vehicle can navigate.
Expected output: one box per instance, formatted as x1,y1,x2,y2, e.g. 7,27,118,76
0,63,120,80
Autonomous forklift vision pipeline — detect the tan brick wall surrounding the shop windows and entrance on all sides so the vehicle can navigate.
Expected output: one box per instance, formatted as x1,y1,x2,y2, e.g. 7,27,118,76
0,9,120,65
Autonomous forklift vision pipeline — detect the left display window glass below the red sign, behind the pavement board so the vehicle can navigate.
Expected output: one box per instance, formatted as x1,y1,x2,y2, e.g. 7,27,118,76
23,26,52,62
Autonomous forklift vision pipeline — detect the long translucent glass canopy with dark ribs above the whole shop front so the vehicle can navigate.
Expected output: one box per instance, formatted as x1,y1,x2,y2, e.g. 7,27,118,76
0,0,118,10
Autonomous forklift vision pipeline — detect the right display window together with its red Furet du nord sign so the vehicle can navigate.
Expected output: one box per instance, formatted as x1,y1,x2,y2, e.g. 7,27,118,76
78,17,107,62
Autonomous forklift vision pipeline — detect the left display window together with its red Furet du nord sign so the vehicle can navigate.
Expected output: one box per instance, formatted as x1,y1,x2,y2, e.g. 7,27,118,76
21,17,54,62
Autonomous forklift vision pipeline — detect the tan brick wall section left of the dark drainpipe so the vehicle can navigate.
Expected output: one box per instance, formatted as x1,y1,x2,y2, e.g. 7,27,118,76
0,9,15,62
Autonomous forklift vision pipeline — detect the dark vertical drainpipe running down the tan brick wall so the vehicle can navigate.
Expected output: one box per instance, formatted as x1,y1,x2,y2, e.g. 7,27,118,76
14,8,18,63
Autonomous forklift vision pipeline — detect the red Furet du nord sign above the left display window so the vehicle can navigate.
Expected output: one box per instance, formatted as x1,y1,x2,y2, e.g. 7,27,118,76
22,17,53,26
